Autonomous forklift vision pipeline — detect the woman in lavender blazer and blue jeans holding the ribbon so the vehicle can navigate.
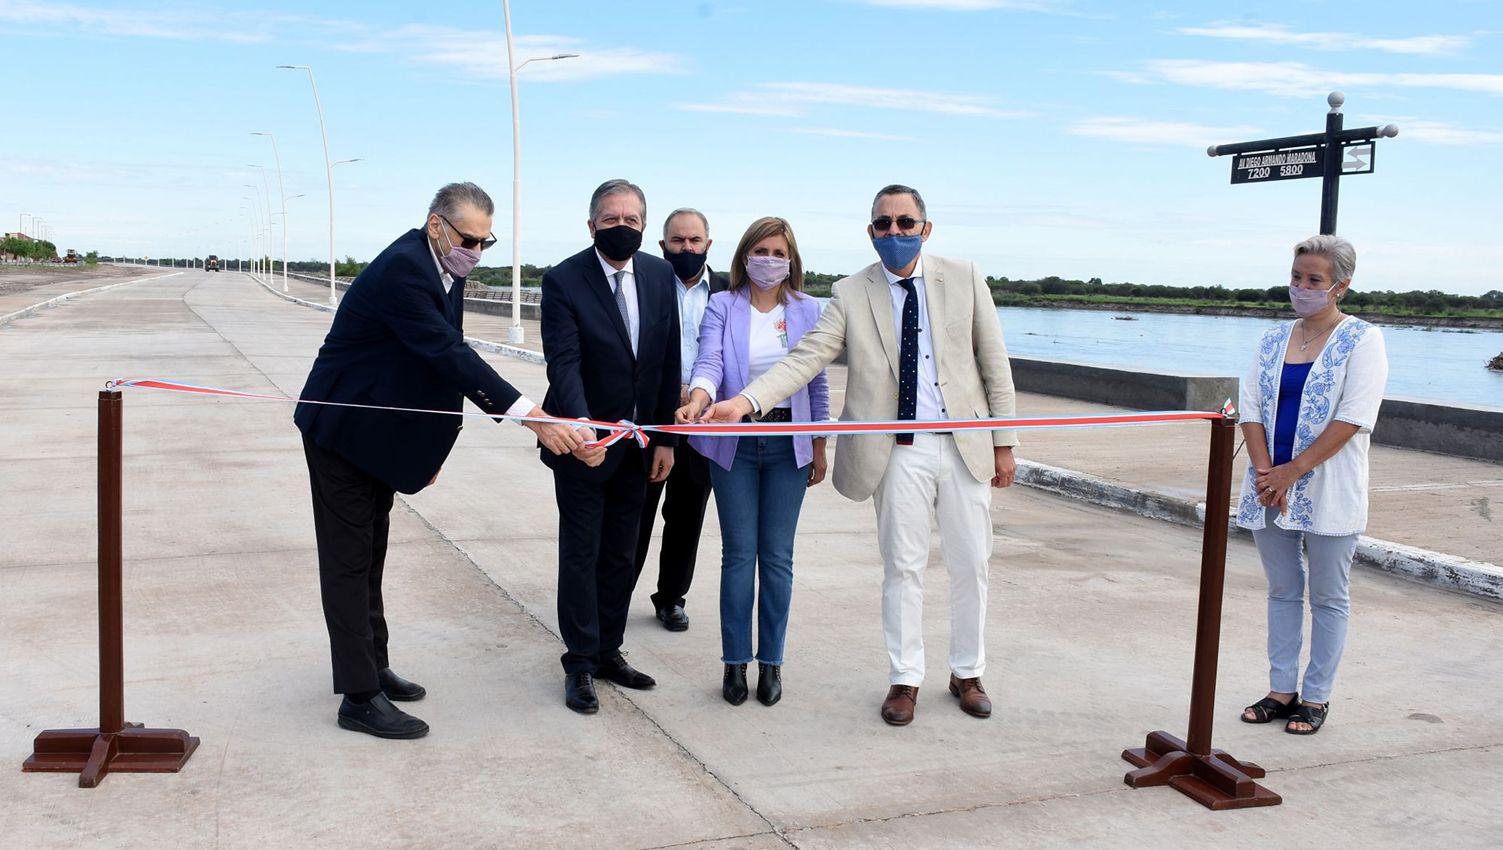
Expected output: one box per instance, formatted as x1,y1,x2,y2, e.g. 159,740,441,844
678,218,830,706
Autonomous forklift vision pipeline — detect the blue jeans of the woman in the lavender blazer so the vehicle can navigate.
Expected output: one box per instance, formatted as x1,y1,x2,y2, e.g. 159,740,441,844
709,437,809,664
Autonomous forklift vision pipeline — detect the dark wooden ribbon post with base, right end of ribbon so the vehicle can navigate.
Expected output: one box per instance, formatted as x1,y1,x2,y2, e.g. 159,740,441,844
1123,416,1284,809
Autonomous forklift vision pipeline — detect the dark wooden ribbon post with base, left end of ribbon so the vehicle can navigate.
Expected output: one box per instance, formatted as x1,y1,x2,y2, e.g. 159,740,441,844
21,389,198,788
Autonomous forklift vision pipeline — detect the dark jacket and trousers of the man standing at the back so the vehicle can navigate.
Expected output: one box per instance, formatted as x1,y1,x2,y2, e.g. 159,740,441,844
633,272,729,611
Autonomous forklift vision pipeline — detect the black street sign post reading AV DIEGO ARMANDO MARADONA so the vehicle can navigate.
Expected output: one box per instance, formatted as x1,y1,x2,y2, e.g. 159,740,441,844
1205,92,1399,233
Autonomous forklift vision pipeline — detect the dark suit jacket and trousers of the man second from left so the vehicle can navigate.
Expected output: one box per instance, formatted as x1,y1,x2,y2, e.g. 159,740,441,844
541,248,679,673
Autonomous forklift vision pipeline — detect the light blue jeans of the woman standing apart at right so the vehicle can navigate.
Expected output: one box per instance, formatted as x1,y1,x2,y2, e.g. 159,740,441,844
1252,508,1357,703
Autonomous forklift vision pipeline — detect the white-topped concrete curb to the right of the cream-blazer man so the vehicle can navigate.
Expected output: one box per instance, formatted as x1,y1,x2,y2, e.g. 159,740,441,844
1018,461,1503,602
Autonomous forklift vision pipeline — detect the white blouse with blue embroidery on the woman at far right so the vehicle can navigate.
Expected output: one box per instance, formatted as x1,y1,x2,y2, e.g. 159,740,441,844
1237,315,1389,536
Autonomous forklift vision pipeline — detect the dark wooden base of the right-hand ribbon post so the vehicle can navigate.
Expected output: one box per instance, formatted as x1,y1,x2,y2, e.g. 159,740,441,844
1123,731,1284,809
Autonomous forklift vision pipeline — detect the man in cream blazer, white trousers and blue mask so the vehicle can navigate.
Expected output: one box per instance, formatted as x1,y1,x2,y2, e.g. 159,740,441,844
705,185,1018,725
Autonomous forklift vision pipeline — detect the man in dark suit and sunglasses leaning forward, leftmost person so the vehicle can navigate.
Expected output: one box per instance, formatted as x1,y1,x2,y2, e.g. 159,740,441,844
293,183,585,737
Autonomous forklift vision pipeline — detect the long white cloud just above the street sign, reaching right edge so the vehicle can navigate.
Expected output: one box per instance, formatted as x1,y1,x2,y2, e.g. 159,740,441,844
1130,59,1503,98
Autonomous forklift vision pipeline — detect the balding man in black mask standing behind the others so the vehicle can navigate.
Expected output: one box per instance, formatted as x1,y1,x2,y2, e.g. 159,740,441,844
636,207,729,632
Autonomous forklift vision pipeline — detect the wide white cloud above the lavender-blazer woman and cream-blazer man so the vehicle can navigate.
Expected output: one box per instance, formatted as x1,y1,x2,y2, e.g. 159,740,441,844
676,83,1031,119
